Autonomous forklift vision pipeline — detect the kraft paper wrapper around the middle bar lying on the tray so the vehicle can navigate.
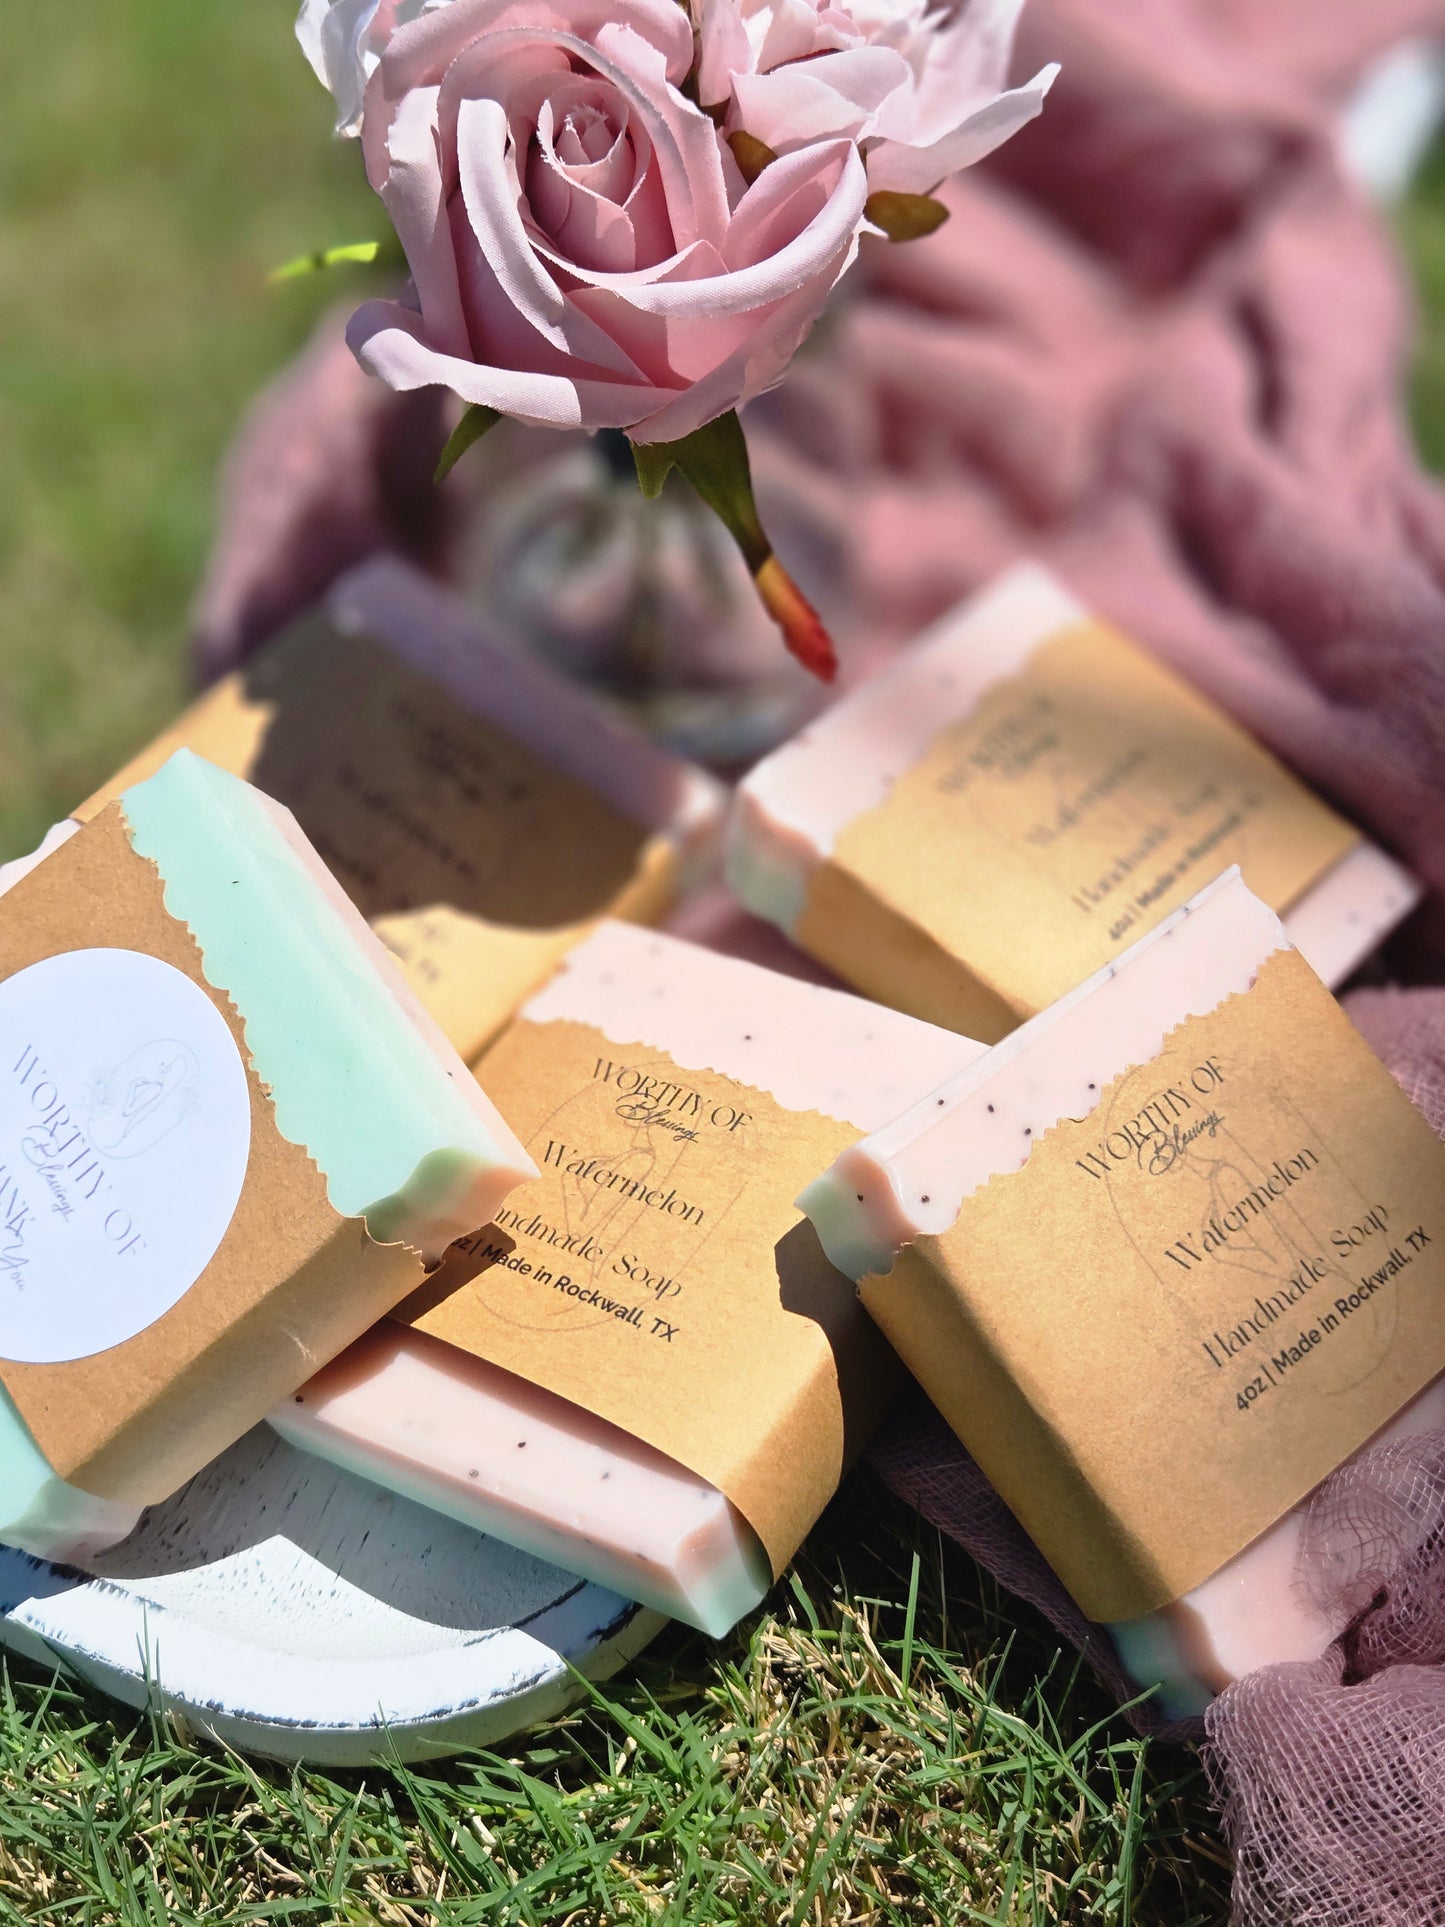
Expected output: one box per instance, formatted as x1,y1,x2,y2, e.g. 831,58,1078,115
399,1019,898,1574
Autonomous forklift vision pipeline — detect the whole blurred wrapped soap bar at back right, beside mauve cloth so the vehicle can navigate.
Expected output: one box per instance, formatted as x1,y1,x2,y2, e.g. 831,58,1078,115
728,567,1418,1043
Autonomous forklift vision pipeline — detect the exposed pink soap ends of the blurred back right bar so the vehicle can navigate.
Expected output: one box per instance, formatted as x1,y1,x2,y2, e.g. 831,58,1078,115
726,563,1420,985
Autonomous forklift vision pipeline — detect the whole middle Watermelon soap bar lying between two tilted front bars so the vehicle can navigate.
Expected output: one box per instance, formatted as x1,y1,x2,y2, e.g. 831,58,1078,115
272,923,979,1634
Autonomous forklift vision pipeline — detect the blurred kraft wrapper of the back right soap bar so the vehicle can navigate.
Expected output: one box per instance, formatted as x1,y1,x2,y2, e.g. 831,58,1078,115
798,622,1358,1043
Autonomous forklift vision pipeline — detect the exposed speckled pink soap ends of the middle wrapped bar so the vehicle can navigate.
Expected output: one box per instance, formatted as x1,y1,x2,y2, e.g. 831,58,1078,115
272,923,981,1634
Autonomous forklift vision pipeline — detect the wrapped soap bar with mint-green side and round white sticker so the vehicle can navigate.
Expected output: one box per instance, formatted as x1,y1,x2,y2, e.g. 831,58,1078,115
0,752,536,1561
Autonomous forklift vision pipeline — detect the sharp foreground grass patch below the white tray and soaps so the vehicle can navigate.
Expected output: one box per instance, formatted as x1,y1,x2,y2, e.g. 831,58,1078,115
0,1476,1227,1927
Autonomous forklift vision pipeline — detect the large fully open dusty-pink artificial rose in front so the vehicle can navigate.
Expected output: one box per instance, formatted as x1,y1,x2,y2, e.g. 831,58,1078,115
349,0,867,441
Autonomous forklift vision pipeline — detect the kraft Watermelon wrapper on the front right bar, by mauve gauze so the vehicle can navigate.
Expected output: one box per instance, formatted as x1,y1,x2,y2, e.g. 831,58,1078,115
861,950,1445,1621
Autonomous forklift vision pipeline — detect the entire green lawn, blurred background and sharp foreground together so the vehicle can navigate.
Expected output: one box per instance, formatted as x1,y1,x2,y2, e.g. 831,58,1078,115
0,0,1445,1927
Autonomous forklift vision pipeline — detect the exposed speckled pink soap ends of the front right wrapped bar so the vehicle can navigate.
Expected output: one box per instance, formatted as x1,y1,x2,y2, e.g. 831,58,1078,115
800,871,1445,1717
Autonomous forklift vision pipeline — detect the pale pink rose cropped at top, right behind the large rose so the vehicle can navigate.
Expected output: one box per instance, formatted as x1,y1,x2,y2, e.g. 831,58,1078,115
697,0,1058,195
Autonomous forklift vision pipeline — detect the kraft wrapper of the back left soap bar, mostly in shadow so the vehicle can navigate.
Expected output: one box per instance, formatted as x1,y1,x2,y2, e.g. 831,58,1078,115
75,617,676,1064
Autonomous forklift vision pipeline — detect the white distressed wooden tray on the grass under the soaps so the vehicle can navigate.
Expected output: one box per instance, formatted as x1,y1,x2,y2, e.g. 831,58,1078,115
0,1426,665,1767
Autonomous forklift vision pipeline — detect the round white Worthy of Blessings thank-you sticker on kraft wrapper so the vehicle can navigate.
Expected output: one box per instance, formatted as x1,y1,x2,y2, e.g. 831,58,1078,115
0,950,250,1364
